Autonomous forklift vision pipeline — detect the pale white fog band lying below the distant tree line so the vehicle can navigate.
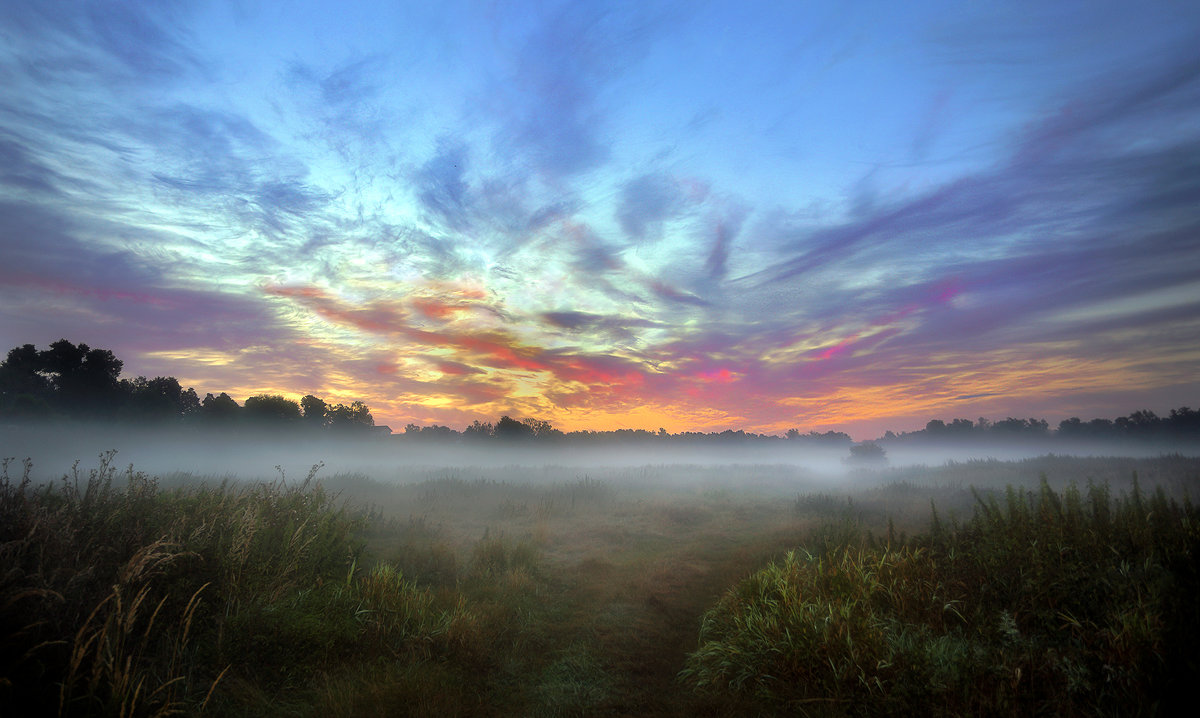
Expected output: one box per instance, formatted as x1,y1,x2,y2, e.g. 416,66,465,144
0,423,1200,490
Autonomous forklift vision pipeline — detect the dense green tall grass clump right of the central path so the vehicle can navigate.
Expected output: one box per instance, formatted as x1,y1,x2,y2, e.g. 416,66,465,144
680,480,1200,714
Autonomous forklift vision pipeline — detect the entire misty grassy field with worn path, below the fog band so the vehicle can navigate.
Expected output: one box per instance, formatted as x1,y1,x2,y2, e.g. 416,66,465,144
0,454,1200,716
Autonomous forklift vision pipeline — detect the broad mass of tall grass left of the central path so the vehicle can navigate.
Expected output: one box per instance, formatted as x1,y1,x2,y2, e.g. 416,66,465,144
0,453,496,716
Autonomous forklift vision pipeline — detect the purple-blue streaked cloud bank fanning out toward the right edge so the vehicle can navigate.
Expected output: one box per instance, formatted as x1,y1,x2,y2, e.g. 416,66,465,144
756,46,1200,355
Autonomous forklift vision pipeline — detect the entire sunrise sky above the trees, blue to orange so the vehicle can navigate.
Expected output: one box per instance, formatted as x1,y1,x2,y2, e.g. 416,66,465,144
0,0,1200,438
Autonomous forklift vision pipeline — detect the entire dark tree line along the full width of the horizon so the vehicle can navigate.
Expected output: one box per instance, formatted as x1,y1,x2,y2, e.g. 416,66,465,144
0,339,1200,448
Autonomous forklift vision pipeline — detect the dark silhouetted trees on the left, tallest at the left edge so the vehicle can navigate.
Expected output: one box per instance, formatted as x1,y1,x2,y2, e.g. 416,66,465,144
0,339,374,431
